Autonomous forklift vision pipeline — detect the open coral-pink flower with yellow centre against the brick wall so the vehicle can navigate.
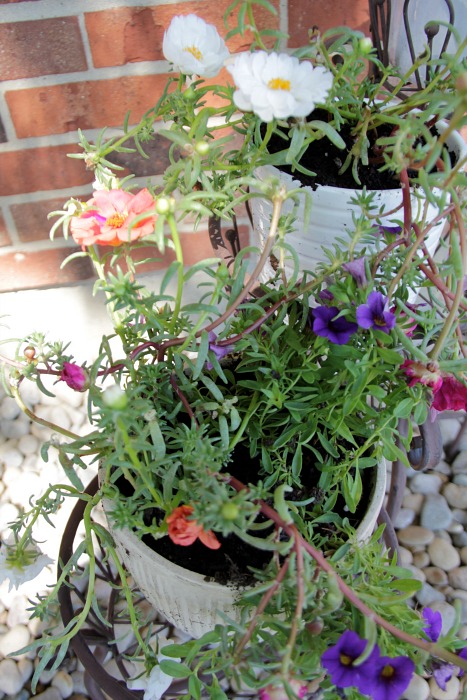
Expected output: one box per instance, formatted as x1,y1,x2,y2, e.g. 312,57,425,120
70,188,156,248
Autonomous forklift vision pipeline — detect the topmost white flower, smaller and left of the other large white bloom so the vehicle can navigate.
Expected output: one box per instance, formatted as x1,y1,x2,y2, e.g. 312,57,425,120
162,15,229,78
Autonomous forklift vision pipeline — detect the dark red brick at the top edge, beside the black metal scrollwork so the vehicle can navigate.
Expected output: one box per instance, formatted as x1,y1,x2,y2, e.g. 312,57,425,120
288,0,370,47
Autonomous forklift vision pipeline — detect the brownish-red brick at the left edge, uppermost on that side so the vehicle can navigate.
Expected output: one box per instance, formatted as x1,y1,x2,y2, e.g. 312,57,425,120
0,17,87,80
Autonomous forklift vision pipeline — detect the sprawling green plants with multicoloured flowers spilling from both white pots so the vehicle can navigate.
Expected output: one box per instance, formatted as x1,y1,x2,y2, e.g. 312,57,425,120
2,2,467,700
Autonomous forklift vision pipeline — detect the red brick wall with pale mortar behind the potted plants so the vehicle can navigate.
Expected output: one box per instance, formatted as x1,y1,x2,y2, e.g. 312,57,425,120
0,0,368,292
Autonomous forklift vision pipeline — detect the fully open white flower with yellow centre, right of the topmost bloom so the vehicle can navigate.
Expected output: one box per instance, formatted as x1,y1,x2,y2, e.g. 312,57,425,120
227,51,333,122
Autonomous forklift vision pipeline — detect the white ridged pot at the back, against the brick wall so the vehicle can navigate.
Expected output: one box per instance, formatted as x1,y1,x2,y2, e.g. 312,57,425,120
251,127,466,282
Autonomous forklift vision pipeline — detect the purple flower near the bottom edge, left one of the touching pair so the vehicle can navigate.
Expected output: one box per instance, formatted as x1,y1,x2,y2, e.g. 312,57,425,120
321,630,379,694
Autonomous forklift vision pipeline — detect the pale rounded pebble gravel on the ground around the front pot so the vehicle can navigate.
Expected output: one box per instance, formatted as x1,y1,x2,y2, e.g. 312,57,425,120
0,385,467,700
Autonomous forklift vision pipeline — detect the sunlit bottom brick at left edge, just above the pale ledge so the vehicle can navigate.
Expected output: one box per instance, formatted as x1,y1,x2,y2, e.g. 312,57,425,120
0,248,94,292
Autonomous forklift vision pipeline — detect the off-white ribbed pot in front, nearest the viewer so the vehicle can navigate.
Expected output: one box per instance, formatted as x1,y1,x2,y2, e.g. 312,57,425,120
100,462,386,637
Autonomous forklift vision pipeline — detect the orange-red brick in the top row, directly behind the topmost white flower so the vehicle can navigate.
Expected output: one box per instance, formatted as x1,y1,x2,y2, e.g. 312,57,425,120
85,0,278,68
